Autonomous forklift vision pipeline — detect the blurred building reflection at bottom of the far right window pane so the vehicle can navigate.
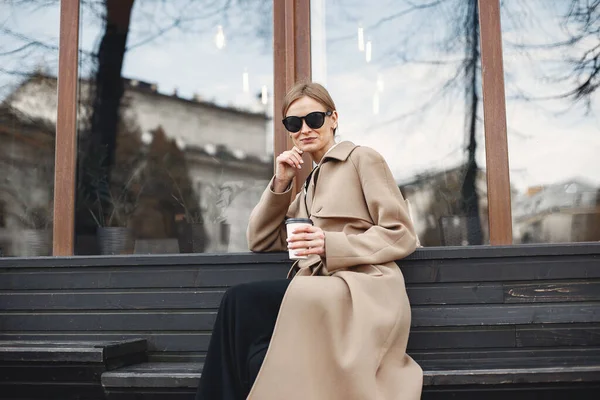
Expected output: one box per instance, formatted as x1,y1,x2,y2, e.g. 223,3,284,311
512,180,600,243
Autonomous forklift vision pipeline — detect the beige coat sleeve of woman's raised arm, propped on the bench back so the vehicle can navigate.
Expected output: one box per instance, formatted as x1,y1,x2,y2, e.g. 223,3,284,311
246,178,300,252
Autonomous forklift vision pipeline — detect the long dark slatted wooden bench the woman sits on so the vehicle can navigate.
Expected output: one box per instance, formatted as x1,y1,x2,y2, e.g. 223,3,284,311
0,244,600,400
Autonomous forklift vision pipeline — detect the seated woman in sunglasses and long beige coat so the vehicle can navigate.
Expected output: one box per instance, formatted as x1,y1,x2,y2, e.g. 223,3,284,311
197,83,422,400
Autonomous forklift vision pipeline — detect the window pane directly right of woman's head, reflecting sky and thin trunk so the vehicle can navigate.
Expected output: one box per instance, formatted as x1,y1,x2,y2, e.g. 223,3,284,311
311,0,489,246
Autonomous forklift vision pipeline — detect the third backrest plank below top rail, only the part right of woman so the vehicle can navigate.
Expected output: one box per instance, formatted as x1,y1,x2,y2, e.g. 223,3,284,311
412,303,600,327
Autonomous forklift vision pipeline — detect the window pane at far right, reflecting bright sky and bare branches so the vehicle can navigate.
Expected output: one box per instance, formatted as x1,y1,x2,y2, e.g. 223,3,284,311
502,0,600,243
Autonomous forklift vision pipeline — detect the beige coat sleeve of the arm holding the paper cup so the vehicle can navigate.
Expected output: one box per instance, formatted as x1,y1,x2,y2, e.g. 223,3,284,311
325,147,416,273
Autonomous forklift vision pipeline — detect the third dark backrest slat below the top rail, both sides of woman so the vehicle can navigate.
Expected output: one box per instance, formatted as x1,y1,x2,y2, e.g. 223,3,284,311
8,303,600,331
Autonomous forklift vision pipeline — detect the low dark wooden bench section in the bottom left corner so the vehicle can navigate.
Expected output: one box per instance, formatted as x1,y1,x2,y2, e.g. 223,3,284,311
0,339,147,399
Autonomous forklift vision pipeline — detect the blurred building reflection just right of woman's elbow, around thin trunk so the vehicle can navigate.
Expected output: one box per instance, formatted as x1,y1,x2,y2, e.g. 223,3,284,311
399,167,489,246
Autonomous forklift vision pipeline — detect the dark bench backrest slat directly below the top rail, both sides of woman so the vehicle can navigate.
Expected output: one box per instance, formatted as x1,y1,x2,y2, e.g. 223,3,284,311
0,256,600,290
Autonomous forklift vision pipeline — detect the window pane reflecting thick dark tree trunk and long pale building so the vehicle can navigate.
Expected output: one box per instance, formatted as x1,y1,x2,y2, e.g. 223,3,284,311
76,0,273,254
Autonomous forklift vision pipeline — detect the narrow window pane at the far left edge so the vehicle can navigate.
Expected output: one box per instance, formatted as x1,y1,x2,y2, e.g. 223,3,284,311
0,1,60,257
